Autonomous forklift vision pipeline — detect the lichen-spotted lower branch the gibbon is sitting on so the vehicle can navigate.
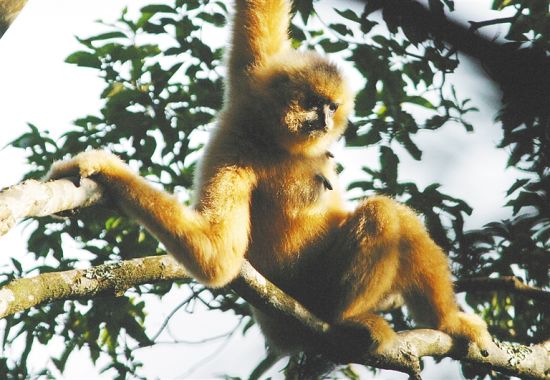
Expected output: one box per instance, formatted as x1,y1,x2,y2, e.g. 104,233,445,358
0,255,550,379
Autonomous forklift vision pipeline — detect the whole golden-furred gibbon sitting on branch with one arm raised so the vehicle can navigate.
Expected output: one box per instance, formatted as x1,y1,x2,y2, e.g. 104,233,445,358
48,0,491,360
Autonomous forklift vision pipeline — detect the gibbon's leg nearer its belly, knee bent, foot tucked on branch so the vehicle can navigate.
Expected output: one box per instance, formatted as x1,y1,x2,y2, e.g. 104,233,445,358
325,197,401,350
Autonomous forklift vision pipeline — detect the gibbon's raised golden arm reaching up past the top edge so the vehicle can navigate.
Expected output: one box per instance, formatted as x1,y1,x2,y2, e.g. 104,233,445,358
228,0,290,81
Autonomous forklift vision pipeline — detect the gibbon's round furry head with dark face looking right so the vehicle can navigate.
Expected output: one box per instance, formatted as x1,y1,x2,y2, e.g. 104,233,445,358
251,50,353,155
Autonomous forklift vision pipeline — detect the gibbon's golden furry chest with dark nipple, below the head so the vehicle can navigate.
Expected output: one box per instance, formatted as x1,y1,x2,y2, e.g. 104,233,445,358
247,157,341,281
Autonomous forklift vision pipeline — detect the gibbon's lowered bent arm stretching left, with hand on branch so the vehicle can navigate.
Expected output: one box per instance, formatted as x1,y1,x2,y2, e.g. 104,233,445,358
47,150,253,287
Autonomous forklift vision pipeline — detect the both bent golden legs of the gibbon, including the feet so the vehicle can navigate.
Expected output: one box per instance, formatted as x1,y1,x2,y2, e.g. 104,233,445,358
329,196,491,351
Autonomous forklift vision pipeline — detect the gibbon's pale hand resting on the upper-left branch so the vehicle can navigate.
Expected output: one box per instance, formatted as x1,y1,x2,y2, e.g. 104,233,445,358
44,150,125,180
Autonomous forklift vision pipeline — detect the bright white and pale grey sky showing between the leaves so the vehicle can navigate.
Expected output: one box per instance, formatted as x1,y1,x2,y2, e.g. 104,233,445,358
0,0,515,379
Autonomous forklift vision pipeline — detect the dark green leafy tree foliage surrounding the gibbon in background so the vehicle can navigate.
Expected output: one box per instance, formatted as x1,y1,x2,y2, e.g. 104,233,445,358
0,0,550,378
